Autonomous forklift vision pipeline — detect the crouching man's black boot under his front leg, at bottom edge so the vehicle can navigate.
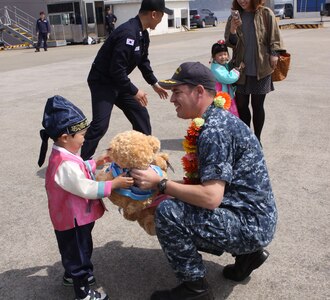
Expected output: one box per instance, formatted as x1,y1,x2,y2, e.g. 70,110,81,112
150,278,214,300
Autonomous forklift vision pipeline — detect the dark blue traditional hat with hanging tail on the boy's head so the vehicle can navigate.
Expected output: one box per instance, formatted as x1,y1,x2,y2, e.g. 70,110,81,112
38,95,89,167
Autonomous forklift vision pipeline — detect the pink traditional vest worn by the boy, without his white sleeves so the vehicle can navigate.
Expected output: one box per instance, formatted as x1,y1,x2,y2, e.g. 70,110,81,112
46,149,105,231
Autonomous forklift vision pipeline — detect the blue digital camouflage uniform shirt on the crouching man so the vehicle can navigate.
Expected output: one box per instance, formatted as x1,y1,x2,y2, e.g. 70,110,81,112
197,105,277,246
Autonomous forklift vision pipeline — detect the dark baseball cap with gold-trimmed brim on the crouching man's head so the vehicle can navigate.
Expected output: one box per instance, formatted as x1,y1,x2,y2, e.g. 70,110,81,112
158,62,216,91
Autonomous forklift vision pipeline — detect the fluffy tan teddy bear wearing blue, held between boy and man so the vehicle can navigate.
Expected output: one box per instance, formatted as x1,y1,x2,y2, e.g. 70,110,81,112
96,130,169,235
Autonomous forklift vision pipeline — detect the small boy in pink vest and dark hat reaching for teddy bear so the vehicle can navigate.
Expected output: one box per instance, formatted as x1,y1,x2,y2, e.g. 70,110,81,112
38,96,133,300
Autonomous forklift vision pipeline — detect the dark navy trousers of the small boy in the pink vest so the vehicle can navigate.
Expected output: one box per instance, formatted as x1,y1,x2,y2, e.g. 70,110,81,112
55,222,95,298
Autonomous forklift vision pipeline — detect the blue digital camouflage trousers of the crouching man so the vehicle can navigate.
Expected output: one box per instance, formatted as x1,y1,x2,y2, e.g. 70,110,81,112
155,199,275,281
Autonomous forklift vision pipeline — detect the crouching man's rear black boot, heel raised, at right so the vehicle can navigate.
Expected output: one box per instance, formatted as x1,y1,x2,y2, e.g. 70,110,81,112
222,249,269,281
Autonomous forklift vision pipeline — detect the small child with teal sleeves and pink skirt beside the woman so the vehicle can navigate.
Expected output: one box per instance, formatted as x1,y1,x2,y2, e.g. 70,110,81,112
211,40,241,117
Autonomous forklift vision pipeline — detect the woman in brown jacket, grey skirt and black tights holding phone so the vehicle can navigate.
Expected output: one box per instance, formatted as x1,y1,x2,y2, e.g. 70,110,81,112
225,0,281,141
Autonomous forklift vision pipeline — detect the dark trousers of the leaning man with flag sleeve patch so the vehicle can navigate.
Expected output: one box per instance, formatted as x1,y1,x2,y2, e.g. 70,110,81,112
81,81,151,160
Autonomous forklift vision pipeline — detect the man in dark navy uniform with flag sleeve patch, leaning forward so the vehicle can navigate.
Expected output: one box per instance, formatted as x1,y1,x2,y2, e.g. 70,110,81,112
81,0,173,159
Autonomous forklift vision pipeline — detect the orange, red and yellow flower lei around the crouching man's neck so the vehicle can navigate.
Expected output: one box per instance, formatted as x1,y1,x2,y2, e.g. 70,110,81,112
181,92,231,184
